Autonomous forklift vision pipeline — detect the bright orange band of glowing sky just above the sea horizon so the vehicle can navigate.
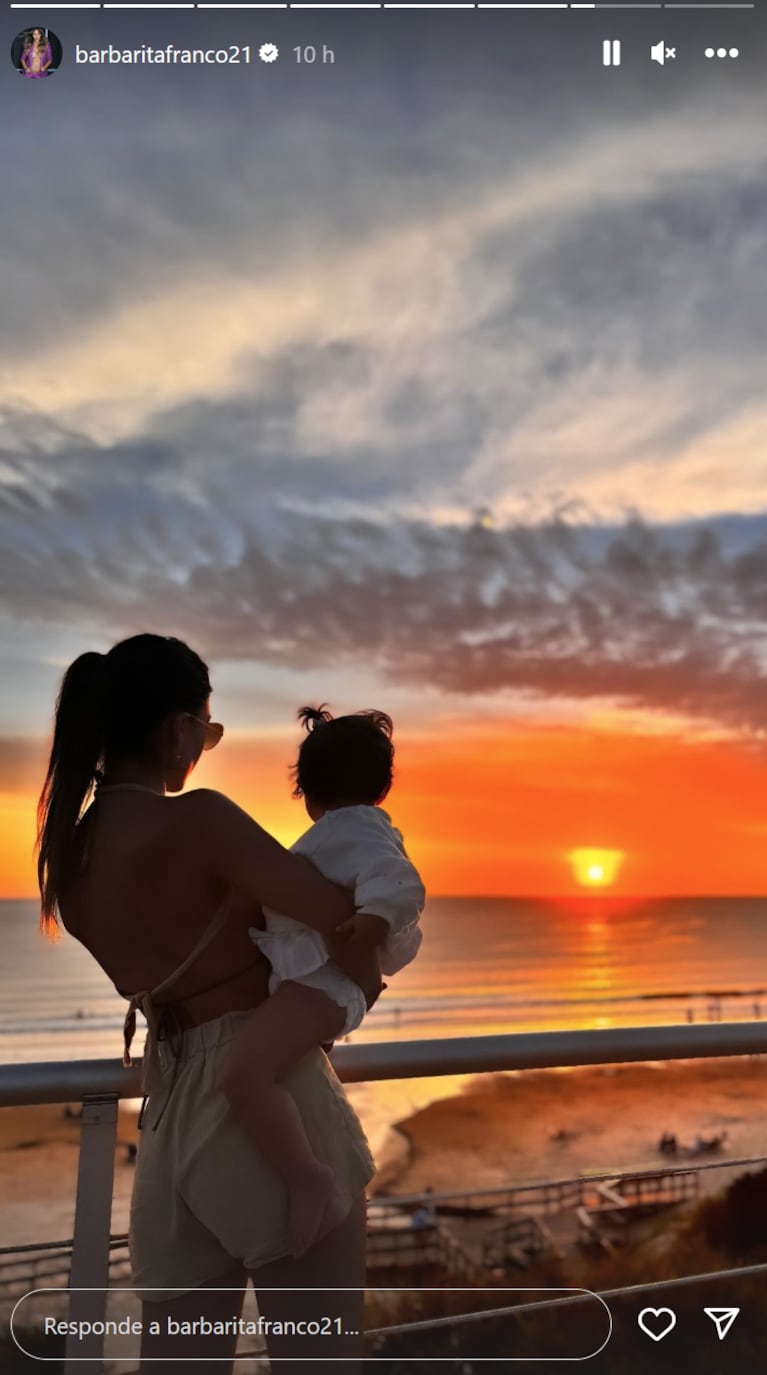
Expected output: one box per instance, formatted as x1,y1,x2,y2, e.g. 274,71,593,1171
0,720,767,901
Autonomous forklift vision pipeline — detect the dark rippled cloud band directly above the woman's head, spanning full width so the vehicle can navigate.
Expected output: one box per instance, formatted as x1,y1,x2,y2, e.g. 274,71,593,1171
0,423,767,729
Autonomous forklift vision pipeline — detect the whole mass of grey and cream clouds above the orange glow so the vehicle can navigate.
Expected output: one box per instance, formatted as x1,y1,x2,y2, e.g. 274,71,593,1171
0,24,767,729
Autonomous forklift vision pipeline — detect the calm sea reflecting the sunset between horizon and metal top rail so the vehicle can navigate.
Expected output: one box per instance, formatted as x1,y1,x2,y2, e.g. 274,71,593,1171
0,895,767,1063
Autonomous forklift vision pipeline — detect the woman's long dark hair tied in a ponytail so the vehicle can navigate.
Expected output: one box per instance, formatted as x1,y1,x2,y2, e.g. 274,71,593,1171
37,635,210,935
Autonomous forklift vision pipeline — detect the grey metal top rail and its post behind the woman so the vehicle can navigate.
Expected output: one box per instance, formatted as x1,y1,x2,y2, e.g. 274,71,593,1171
0,1022,767,1375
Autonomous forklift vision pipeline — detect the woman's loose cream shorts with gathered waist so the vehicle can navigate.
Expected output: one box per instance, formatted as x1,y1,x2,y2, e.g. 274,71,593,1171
131,1012,375,1298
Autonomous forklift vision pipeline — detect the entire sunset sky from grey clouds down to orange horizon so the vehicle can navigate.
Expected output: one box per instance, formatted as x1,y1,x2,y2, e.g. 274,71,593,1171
0,12,767,897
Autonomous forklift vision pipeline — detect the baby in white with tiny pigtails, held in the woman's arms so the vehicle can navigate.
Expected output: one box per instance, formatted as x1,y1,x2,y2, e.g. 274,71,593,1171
221,707,425,1255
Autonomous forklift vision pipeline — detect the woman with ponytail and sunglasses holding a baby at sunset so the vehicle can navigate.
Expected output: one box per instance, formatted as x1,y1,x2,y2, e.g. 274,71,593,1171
38,635,381,1375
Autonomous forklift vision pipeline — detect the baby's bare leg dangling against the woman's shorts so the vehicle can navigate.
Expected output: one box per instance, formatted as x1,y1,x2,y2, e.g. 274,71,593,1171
221,980,346,1255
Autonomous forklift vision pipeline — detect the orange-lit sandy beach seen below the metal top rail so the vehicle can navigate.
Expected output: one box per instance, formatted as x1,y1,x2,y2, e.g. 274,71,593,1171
0,1057,767,1246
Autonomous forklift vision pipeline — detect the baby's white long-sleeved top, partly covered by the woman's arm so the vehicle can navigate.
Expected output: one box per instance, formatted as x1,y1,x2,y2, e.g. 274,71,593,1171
258,807,426,979
